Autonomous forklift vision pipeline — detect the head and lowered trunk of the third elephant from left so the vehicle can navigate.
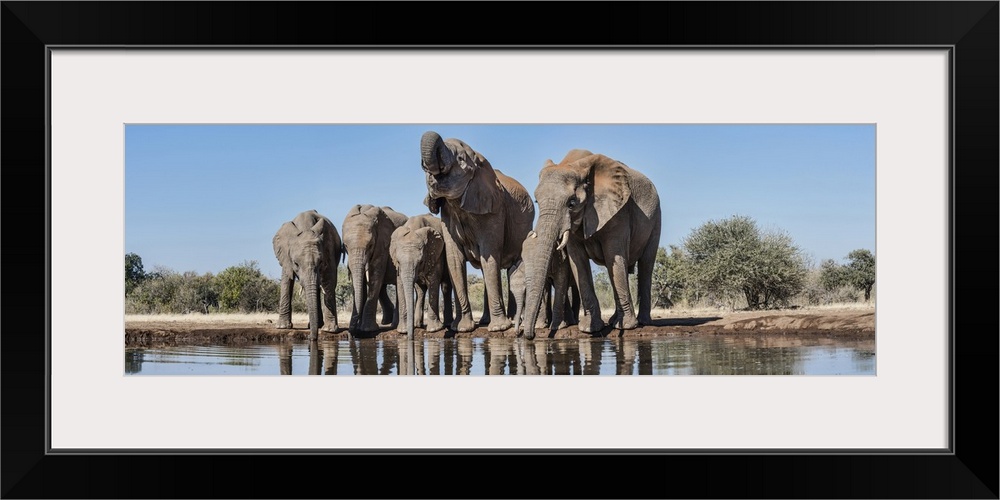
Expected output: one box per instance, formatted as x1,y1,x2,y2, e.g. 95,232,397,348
389,225,447,338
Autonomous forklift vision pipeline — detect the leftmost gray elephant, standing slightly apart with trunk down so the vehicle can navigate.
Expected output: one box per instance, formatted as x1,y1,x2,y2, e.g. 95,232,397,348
272,210,343,340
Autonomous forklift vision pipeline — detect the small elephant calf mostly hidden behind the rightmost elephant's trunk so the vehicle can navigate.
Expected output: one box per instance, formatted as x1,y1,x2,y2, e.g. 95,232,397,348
509,231,580,338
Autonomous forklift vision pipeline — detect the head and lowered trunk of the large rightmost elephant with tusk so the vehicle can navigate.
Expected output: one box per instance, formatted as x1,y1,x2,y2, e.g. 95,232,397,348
524,149,632,339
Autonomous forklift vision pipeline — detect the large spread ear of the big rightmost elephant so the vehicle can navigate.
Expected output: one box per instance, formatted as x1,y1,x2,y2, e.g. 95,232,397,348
573,154,632,238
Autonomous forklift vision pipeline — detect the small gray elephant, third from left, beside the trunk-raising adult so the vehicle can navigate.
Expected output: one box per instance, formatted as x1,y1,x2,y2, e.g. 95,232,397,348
389,214,452,337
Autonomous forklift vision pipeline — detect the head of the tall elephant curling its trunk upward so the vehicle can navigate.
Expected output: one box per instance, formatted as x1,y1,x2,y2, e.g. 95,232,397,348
420,131,503,215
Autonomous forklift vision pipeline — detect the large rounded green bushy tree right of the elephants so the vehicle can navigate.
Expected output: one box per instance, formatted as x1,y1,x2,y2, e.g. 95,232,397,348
684,215,807,309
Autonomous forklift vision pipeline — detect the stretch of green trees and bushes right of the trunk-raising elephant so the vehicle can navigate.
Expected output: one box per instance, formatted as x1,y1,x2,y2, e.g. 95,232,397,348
594,216,875,310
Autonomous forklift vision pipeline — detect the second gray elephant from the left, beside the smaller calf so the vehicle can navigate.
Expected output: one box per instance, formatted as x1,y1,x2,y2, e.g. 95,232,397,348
341,205,407,333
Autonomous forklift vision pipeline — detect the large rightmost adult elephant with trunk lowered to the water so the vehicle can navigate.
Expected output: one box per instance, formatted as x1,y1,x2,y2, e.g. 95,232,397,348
524,149,660,339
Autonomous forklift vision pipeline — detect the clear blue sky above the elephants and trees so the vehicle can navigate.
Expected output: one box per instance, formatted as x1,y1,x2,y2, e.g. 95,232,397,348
124,124,875,278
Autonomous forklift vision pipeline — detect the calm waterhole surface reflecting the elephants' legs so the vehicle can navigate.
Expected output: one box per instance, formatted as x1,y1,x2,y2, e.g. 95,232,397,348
125,336,875,375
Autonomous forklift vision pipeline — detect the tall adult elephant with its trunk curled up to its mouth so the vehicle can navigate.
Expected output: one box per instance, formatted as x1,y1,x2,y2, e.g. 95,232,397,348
420,131,535,332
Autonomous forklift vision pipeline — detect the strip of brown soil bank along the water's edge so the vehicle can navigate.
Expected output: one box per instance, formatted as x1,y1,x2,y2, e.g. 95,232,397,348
125,309,875,346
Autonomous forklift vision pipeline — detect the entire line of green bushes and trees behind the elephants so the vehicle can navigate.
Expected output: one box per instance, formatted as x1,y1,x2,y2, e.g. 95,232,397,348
125,216,875,317
